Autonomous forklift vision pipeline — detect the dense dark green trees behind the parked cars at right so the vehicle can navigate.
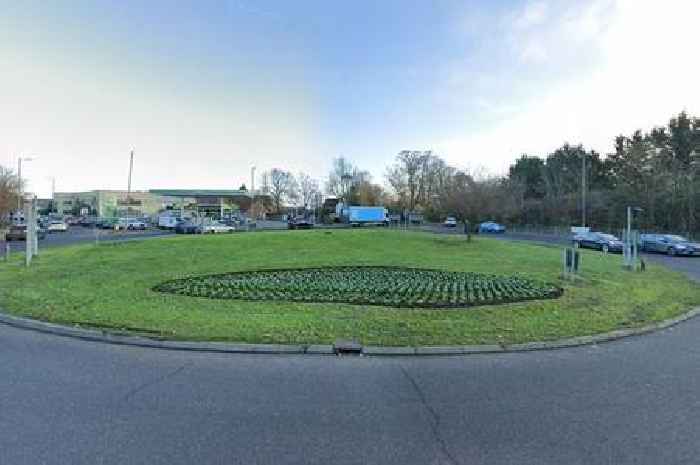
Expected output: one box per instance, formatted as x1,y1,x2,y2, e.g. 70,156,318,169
502,112,700,233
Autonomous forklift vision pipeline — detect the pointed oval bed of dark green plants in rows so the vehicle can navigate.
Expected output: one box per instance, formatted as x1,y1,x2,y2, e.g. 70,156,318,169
153,266,562,308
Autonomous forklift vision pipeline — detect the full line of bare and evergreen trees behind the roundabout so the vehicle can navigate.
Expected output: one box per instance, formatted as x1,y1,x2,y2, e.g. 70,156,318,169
0,112,700,233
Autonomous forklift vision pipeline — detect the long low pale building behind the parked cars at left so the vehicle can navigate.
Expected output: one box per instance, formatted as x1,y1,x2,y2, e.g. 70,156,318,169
54,189,270,218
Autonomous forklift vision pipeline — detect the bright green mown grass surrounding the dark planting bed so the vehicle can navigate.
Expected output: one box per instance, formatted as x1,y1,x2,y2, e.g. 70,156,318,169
0,230,700,345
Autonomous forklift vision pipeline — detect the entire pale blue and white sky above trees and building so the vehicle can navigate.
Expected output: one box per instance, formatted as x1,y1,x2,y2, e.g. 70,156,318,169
0,0,700,195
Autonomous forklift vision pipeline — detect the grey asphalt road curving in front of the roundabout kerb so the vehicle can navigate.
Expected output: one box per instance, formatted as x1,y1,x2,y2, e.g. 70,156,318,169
0,227,700,465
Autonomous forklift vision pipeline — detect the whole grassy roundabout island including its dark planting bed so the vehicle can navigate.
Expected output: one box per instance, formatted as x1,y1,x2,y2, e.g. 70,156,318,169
0,230,700,348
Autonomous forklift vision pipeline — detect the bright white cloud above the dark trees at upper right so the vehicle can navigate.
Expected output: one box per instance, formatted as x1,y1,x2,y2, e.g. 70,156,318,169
437,0,700,172
